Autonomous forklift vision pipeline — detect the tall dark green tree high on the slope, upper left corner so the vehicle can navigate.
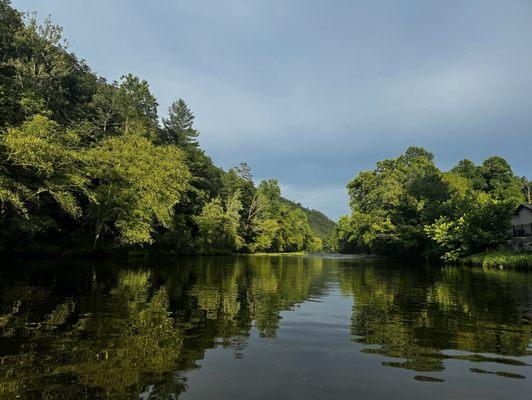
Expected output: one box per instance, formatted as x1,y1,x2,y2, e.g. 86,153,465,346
2,10,95,125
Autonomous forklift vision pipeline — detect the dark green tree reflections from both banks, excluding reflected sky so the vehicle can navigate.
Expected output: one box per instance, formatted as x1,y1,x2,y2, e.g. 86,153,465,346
0,256,532,399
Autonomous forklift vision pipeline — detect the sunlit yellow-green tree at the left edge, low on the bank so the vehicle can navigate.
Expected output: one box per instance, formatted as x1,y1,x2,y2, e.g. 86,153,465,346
0,115,87,241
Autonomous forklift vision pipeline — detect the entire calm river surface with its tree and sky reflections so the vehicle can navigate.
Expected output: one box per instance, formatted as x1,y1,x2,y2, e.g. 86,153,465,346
0,256,532,400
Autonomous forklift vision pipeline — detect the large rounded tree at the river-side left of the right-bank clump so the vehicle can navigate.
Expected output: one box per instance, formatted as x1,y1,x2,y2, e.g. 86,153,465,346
343,147,448,256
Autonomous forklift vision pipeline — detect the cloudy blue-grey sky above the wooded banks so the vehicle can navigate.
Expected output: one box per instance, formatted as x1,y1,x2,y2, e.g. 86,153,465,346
12,0,532,219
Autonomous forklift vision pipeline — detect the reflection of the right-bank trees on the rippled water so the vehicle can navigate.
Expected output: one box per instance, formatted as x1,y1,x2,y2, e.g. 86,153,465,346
341,266,532,377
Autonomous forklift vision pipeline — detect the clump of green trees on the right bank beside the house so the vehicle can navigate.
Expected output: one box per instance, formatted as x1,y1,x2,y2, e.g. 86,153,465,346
329,147,531,261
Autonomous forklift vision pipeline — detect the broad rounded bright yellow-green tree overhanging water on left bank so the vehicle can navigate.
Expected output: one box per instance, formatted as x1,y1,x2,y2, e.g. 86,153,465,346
87,131,190,247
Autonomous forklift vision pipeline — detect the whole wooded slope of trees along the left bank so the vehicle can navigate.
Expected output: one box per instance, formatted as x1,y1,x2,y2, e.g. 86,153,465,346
0,0,321,253
